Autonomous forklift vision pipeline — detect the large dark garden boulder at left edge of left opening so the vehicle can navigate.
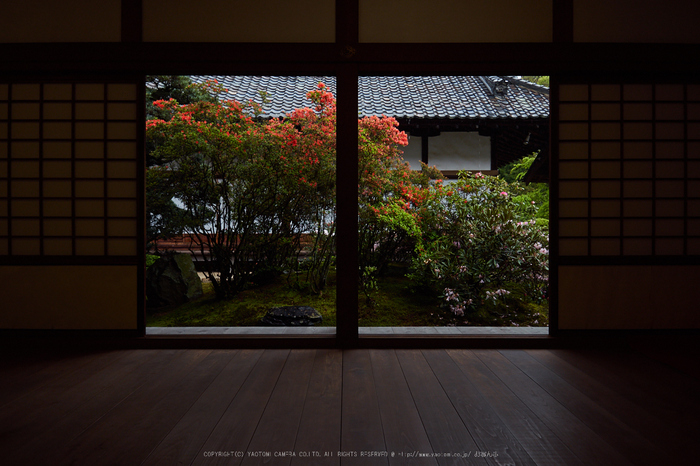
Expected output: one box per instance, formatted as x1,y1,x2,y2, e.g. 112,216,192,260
146,254,203,307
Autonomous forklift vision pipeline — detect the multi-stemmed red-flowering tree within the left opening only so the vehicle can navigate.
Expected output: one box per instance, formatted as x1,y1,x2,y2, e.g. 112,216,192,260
146,84,335,298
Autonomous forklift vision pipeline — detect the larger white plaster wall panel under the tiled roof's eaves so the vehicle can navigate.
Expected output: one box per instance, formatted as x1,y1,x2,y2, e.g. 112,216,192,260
428,132,491,170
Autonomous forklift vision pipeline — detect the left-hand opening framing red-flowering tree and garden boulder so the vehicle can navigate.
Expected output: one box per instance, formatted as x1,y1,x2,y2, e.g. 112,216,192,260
146,76,336,335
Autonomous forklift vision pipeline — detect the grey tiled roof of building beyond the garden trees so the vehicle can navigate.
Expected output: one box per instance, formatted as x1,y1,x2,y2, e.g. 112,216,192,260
191,76,549,119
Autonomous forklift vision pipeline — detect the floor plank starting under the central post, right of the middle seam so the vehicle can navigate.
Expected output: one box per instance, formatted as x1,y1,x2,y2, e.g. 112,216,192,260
341,350,388,465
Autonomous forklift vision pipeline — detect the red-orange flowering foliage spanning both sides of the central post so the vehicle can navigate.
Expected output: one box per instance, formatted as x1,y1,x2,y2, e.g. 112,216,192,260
147,83,438,298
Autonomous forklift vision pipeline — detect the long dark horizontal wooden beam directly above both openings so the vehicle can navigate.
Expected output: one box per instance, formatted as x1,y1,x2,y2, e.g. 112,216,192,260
0,42,700,79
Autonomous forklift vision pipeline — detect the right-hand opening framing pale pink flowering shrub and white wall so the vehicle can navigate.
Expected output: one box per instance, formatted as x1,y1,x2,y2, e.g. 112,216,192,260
358,76,549,335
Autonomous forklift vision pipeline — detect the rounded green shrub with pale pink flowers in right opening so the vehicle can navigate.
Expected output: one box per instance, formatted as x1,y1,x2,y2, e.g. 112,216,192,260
410,172,549,325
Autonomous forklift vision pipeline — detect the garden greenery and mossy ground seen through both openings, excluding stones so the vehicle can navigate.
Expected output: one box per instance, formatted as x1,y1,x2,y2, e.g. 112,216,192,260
146,77,549,326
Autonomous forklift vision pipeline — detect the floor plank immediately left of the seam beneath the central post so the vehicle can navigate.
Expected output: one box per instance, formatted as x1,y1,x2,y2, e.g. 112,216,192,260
291,350,343,466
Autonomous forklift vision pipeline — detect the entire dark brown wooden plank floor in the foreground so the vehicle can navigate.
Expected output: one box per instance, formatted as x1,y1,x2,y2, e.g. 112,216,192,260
0,345,700,465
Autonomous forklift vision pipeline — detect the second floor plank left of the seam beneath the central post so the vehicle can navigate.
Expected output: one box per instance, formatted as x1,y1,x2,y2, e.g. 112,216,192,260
242,350,316,466
